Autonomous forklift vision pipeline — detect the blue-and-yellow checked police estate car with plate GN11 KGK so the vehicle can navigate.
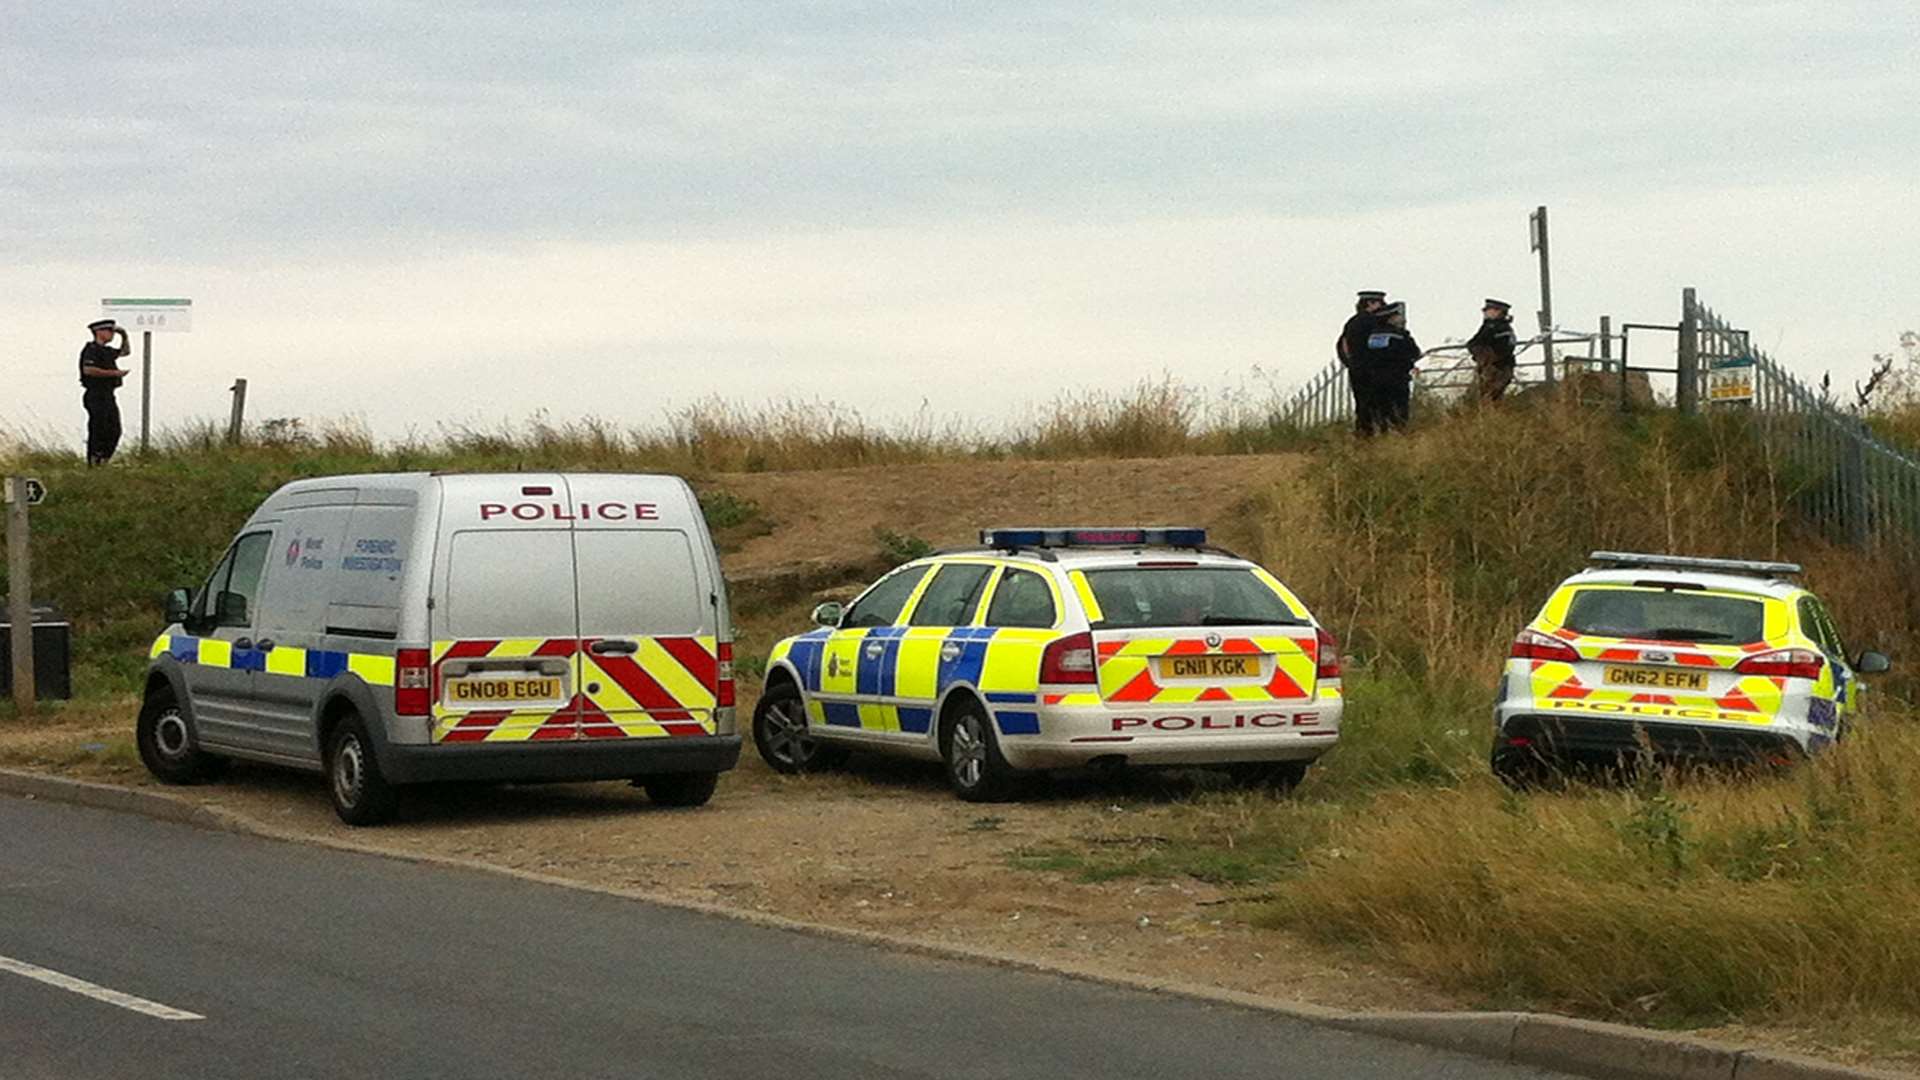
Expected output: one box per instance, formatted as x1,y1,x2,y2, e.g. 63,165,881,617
753,528,1342,801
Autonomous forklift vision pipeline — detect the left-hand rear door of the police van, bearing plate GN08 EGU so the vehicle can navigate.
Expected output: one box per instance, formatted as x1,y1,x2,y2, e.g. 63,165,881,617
430,473,580,744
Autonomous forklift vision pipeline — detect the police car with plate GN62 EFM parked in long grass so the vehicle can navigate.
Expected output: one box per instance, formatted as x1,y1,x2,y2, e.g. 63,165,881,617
1492,552,1887,784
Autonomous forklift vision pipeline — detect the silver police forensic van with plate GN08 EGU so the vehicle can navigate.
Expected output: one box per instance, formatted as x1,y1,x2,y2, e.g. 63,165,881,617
136,473,741,824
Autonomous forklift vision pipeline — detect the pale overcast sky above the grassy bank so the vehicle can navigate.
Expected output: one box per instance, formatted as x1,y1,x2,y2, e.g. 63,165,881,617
0,0,1920,446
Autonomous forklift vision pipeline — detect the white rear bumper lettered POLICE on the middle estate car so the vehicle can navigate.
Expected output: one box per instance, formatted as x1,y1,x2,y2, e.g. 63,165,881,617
1000,703,1340,769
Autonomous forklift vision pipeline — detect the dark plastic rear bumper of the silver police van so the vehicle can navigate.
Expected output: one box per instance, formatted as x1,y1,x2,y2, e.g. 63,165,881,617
380,734,741,784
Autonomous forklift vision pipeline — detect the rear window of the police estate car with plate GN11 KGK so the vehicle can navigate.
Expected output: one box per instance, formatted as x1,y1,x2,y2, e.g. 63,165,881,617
1087,567,1306,630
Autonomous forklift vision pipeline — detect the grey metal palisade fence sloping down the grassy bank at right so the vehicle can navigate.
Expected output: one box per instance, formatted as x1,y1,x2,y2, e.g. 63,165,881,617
1680,290,1920,548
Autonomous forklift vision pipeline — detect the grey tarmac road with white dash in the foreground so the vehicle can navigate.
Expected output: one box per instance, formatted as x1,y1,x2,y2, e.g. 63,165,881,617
0,798,1574,1080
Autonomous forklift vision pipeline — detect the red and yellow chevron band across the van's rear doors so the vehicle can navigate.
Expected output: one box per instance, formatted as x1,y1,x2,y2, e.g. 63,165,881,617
432,638,720,742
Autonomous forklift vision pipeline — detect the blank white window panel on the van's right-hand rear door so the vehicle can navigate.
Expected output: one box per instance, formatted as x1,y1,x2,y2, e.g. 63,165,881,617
574,528,705,638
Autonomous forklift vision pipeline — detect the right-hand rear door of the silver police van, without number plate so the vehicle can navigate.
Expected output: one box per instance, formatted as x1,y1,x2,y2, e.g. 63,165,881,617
568,475,724,738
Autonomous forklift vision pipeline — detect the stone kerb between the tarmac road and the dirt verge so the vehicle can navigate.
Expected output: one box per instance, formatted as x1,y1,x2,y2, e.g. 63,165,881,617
0,769,1916,1080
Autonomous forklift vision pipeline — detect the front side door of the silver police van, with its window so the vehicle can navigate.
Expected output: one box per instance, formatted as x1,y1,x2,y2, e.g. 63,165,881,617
173,523,275,751
